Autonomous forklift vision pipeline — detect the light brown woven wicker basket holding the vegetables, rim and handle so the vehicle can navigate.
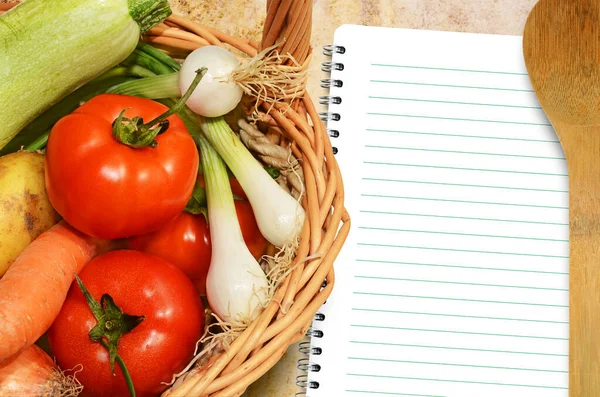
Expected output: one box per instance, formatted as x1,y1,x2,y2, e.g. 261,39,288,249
0,0,350,397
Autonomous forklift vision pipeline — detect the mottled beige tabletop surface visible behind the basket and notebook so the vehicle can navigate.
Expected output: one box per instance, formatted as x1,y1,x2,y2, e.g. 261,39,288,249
169,0,536,397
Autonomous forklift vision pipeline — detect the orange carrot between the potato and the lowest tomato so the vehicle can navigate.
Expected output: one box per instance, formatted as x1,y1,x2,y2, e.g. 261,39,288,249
0,221,108,363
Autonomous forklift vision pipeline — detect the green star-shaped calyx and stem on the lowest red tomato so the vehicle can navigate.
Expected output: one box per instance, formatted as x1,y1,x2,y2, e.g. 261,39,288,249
75,274,146,397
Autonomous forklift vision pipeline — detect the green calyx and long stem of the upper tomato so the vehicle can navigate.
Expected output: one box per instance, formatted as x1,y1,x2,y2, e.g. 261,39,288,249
112,67,208,149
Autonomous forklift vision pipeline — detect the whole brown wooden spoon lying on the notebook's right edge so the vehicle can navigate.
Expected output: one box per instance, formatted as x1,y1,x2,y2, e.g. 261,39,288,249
523,0,600,397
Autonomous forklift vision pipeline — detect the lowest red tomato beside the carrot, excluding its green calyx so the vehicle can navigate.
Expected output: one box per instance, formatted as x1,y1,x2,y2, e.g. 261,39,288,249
48,250,204,397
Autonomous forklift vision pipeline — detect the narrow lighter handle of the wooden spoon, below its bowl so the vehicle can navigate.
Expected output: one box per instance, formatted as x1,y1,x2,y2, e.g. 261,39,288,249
553,122,600,397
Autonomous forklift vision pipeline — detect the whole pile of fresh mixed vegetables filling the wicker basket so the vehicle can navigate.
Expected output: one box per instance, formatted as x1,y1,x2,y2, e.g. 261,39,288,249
0,0,305,397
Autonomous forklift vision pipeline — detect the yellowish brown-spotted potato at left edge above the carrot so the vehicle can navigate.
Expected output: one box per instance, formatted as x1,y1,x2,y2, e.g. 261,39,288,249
0,152,60,277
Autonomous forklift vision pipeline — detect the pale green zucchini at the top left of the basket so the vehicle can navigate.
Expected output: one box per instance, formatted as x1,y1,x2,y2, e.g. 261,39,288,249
0,0,171,149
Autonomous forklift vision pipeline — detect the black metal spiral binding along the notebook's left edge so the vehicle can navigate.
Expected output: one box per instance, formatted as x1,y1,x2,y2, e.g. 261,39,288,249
296,44,346,397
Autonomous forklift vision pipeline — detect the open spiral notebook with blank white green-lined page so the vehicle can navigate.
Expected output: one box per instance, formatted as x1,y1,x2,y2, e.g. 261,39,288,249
298,25,569,397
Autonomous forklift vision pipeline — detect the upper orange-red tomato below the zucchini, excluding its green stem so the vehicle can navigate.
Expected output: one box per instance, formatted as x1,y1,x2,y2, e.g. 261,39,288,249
46,94,199,239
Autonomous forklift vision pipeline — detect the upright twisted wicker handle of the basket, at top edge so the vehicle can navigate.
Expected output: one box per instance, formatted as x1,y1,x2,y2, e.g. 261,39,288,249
259,0,313,64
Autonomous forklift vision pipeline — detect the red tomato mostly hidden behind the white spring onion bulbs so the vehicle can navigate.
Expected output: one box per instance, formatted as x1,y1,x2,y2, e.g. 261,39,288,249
128,200,267,295
